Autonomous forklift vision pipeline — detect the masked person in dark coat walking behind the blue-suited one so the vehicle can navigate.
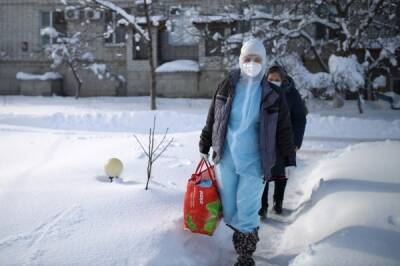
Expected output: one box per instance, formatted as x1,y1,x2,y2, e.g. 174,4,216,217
259,64,307,217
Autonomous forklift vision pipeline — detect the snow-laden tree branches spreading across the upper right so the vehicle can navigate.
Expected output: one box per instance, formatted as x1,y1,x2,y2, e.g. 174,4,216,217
208,0,400,112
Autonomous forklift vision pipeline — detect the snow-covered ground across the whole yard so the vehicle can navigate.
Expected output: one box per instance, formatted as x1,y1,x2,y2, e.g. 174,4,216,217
0,96,400,265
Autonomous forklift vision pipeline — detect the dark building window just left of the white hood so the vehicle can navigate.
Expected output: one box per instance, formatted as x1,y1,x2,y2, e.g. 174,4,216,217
206,23,225,56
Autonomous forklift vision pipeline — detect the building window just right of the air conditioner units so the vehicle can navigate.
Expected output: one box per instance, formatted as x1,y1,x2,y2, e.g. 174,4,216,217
104,9,130,45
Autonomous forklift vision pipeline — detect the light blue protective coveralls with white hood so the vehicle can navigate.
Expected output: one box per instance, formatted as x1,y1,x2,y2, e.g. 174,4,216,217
216,40,266,232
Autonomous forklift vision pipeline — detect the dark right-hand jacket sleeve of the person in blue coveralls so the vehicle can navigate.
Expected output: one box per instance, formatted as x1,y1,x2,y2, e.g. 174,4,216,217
276,94,296,166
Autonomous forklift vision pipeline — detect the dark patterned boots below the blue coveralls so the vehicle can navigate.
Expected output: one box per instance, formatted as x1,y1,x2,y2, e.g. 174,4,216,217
233,228,260,266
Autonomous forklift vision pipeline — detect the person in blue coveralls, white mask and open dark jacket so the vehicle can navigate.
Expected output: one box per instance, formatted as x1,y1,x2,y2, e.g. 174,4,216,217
199,38,295,265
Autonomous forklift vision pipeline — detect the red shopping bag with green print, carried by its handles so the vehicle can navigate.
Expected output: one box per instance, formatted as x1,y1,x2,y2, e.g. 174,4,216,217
183,159,222,236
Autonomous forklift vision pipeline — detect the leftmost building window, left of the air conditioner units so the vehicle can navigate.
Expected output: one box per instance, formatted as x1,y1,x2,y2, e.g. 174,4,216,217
40,11,67,45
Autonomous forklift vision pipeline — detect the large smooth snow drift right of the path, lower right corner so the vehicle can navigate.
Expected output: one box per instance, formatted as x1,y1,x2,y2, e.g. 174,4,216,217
281,141,400,265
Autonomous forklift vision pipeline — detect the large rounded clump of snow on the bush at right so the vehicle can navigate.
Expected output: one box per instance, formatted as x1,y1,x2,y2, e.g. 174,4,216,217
328,55,365,92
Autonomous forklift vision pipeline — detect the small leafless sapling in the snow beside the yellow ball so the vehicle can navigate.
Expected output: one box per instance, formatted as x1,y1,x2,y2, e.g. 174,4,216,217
133,116,174,190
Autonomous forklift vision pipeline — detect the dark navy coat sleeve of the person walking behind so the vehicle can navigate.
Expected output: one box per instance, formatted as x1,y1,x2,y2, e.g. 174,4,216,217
290,88,307,149
